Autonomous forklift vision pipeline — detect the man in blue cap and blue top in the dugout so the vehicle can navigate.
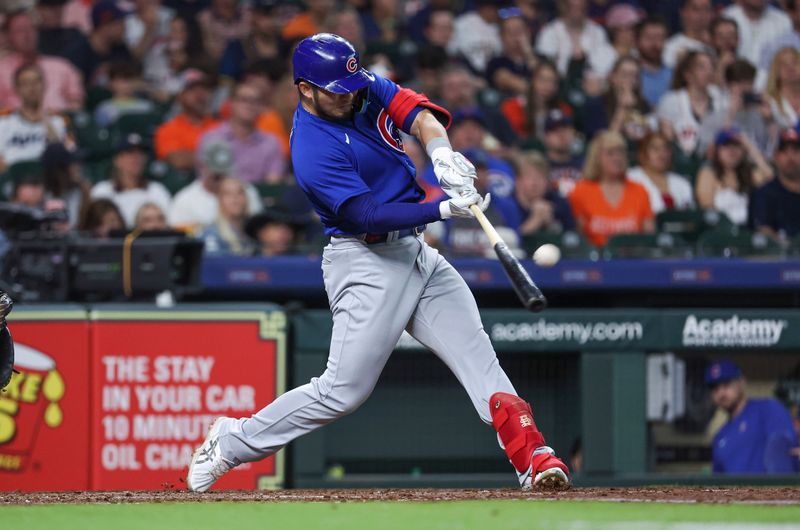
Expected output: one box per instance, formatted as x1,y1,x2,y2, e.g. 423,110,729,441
705,360,800,475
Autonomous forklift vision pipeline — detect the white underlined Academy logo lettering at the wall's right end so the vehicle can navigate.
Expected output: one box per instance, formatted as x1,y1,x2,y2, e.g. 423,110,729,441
683,314,789,346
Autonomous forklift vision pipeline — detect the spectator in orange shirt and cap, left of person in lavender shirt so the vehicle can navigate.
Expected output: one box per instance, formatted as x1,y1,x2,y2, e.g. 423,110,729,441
155,69,217,170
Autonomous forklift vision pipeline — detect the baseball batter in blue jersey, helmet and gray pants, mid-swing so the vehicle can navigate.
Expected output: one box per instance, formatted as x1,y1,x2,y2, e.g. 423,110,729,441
187,33,569,492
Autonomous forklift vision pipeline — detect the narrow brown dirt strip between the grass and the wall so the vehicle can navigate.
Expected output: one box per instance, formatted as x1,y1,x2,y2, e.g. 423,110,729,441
0,487,800,505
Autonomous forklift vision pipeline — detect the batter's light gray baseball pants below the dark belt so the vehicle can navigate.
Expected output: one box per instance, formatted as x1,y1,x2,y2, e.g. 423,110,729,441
220,232,516,464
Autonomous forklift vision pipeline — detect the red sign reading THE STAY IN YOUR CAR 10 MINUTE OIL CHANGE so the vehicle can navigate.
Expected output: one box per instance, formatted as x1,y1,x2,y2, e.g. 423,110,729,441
92,312,285,490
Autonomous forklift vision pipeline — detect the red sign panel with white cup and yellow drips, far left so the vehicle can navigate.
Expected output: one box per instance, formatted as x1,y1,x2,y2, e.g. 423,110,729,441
0,312,90,491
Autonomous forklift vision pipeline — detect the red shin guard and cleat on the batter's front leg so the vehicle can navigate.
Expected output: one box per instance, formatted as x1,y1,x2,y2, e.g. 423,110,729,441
489,392,570,490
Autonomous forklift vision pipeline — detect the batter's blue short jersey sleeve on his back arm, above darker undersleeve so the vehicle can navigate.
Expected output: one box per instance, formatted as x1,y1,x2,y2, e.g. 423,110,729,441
292,138,370,215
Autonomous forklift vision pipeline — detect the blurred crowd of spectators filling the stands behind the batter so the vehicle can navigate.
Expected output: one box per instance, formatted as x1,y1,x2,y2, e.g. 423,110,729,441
0,0,800,256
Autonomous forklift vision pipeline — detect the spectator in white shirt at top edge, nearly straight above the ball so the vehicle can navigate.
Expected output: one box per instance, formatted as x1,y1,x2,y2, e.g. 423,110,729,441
536,0,617,78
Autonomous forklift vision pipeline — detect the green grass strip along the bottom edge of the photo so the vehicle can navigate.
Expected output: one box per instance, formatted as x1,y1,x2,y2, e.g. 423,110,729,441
0,500,800,530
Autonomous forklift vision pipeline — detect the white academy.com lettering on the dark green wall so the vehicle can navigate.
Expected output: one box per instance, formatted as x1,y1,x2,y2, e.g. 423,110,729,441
491,319,644,345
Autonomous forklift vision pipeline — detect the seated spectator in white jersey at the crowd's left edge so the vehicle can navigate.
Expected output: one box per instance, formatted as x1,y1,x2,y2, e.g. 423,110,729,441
0,64,66,172
